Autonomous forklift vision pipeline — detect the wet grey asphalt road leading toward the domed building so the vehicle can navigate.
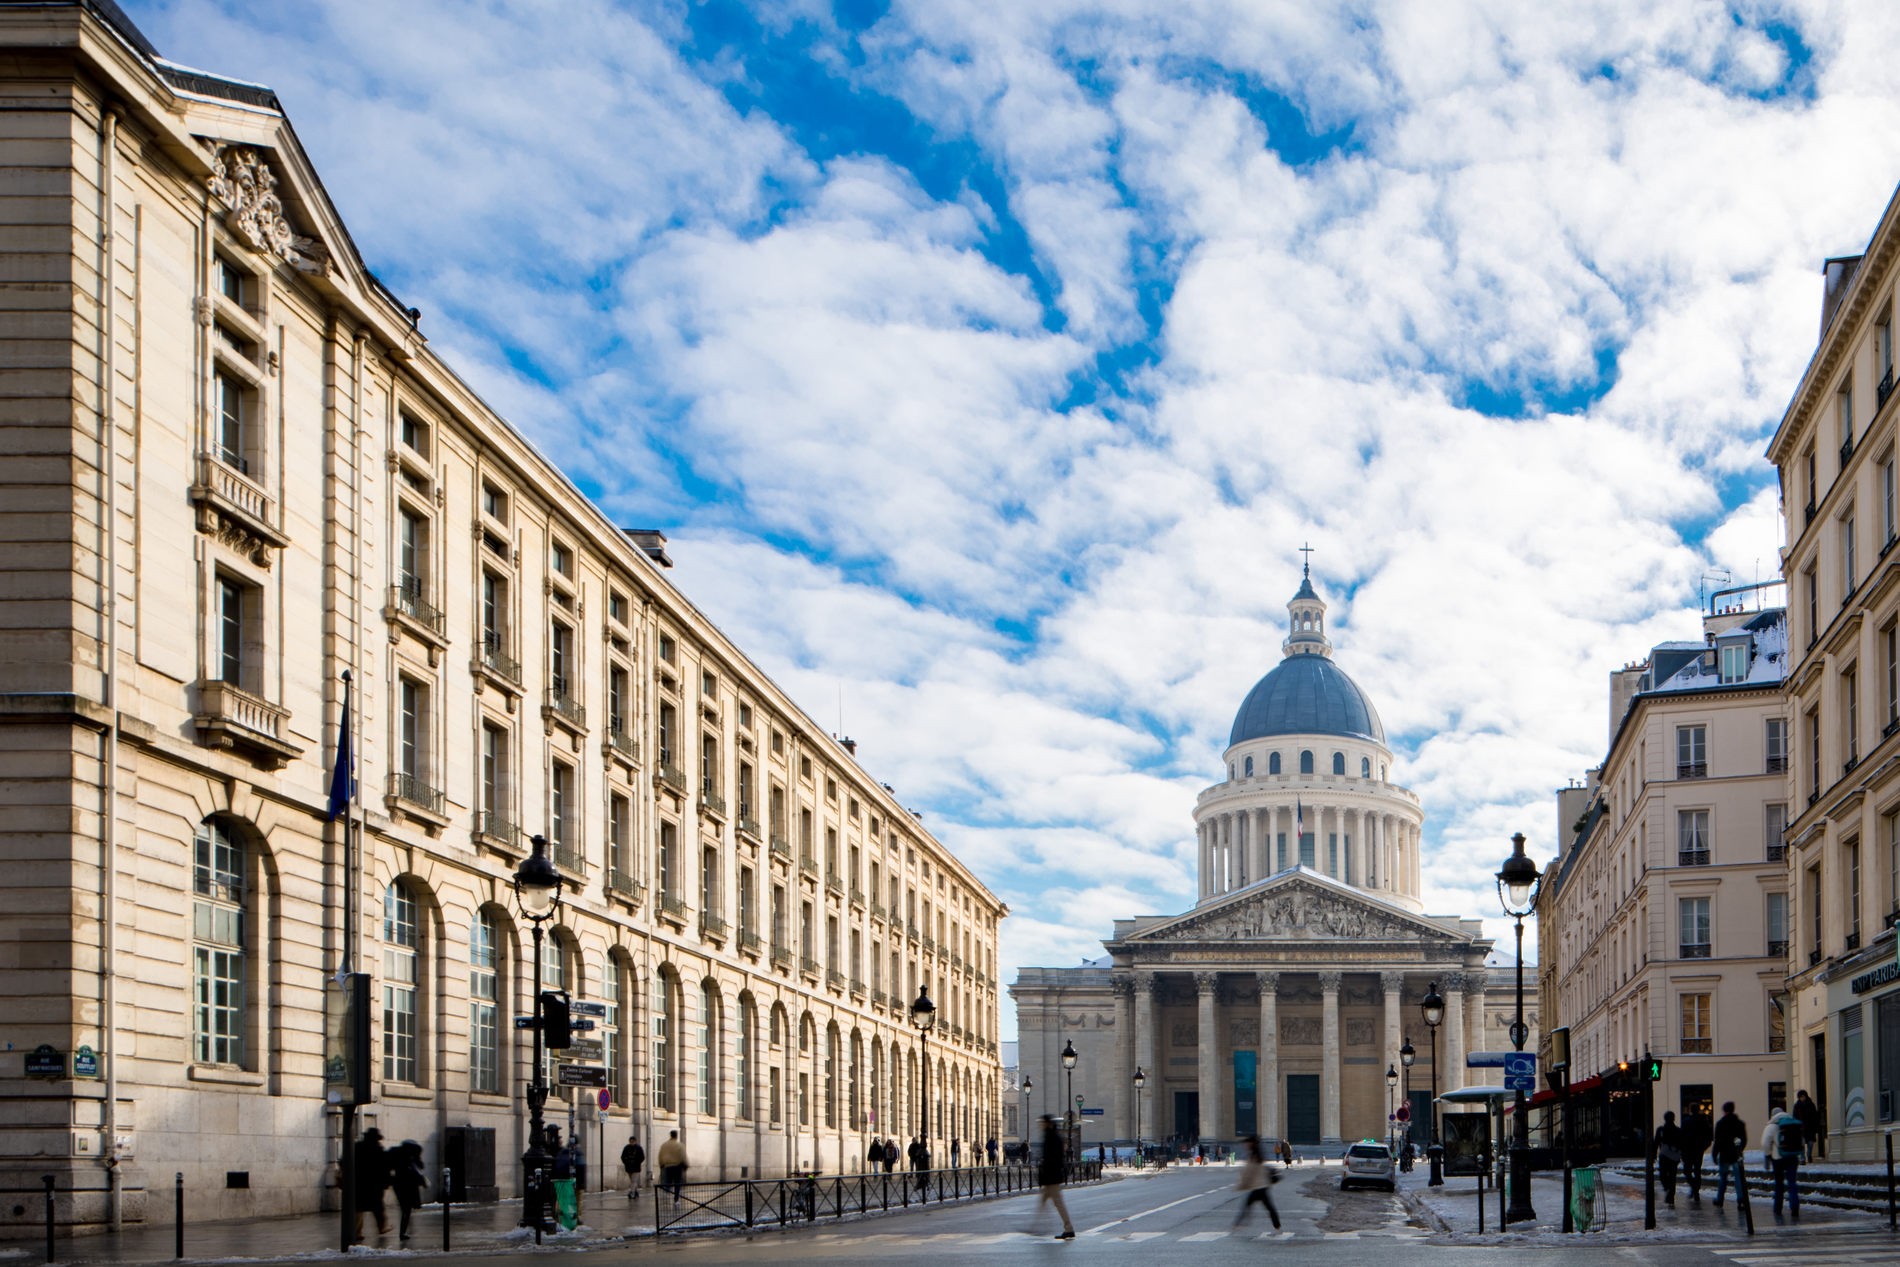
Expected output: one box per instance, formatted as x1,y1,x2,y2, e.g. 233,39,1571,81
378,1166,1896,1267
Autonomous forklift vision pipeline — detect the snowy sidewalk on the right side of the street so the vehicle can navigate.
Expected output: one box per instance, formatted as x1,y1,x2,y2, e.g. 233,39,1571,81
1398,1166,1887,1246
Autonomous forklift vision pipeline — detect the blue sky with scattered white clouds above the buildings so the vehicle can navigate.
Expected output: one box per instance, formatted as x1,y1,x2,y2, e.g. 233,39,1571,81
140,0,1900,1031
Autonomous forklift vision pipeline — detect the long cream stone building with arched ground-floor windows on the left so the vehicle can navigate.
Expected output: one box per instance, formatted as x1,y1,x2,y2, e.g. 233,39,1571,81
0,2,1005,1235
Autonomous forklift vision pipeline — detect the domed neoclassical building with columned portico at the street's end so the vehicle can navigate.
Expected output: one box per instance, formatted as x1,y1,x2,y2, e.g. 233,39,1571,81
1009,576,1535,1147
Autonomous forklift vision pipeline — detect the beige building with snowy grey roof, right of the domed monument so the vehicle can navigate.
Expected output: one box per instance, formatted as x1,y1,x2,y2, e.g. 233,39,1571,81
1537,596,1792,1151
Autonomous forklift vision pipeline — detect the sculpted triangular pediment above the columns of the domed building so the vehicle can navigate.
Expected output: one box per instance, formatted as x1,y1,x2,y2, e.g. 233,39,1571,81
1117,866,1482,944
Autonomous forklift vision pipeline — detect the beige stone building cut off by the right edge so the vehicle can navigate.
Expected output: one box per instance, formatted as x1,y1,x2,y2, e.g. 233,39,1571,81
1769,183,1900,1159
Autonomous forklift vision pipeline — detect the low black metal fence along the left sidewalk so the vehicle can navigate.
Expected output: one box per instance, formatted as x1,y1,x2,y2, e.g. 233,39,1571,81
654,1161,1102,1233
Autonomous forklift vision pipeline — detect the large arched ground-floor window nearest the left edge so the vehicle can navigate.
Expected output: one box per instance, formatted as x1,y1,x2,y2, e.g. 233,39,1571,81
192,819,251,1068
